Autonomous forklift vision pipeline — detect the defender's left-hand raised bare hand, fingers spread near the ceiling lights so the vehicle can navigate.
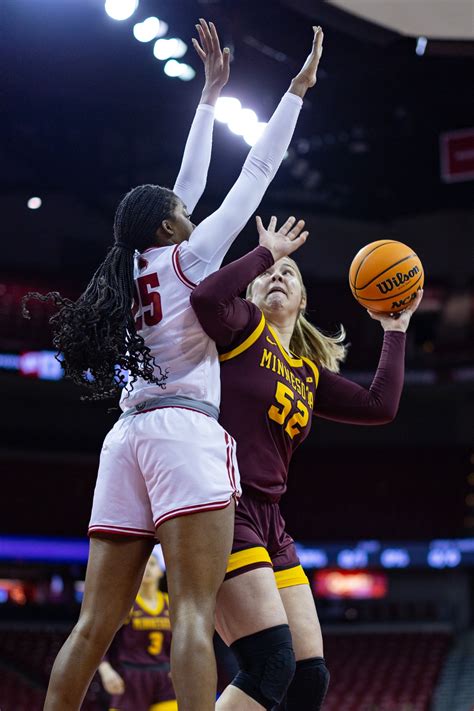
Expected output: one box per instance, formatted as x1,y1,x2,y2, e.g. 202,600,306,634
193,18,230,103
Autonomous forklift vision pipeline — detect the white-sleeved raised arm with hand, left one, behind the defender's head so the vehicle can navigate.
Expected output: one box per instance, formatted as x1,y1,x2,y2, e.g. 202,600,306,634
173,19,230,213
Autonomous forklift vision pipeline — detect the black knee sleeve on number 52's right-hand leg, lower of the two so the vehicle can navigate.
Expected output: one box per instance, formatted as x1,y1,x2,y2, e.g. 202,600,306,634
286,657,329,711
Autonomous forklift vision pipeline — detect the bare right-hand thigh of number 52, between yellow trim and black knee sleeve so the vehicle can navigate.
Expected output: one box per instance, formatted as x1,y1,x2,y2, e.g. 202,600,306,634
279,585,323,661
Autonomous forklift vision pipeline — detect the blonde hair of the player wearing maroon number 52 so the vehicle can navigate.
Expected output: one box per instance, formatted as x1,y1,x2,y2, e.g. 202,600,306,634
246,257,347,373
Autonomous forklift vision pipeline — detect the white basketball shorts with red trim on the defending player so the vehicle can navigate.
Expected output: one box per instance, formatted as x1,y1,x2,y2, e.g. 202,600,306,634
89,407,241,538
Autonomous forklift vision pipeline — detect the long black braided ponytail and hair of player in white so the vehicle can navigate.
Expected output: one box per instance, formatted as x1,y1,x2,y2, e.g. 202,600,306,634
22,185,177,400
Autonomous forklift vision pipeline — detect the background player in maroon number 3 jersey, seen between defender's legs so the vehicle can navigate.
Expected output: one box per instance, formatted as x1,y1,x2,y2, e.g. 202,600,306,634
99,555,178,711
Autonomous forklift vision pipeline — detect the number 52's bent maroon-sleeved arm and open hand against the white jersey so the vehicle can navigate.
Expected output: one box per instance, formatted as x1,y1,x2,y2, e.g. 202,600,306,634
191,217,308,348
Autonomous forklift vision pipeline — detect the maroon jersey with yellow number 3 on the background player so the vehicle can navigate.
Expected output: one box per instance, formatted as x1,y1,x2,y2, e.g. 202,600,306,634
108,591,171,665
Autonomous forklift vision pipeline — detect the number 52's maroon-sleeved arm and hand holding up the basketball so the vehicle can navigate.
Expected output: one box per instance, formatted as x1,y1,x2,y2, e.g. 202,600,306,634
314,292,422,425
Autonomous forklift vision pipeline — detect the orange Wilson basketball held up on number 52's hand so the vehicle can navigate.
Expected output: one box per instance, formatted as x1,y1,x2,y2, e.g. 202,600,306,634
349,239,425,313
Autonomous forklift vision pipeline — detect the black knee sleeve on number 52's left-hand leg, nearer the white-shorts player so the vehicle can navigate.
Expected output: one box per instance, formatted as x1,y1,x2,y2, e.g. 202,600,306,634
231,625,295,709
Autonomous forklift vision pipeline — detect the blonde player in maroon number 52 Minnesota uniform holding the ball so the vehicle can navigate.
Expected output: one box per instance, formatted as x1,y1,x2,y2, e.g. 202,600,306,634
191,218,421,711
